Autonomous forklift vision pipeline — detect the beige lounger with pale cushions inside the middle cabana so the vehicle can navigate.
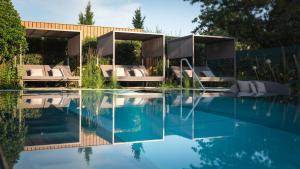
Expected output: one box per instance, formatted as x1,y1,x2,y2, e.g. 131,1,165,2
100,65,164,82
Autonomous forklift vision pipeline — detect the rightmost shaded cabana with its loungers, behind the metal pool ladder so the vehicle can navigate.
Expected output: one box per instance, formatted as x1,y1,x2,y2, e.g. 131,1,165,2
167,34,236,82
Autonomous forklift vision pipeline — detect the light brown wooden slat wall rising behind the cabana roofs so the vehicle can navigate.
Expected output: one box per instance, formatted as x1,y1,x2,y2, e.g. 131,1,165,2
22,21,143,39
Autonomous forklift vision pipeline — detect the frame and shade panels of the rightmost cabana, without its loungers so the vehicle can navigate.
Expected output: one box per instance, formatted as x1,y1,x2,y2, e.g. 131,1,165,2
167,34,236,82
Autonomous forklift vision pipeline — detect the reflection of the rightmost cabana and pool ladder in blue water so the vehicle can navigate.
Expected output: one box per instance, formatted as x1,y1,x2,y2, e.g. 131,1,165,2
165,91,236,140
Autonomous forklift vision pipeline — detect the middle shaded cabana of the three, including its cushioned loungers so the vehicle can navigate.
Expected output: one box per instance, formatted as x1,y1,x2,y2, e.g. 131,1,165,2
97,31,165,82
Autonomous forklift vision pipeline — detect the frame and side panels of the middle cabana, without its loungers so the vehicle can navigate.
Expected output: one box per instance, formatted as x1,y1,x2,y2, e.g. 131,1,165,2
97,31,166,81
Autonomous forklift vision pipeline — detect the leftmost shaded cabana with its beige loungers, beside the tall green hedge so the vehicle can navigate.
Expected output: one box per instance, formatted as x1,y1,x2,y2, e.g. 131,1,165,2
20,28,82,86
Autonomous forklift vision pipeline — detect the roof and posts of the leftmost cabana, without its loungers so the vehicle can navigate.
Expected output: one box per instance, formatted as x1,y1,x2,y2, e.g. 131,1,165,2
20,28,82,86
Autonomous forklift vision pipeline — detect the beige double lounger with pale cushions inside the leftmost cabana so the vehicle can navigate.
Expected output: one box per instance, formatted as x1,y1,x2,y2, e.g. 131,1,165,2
18,65,80,85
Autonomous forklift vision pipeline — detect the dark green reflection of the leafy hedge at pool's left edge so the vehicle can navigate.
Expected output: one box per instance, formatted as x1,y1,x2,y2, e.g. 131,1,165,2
0,93,27,168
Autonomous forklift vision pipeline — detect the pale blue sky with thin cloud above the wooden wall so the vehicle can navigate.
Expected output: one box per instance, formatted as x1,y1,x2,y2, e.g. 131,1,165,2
12,0,200,36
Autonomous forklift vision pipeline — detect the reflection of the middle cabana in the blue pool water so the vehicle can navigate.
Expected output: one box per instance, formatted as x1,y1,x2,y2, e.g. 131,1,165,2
97,92,165,144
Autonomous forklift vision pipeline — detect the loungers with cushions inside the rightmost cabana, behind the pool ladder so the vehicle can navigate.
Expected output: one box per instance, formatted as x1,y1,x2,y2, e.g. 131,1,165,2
171,66,234,82
